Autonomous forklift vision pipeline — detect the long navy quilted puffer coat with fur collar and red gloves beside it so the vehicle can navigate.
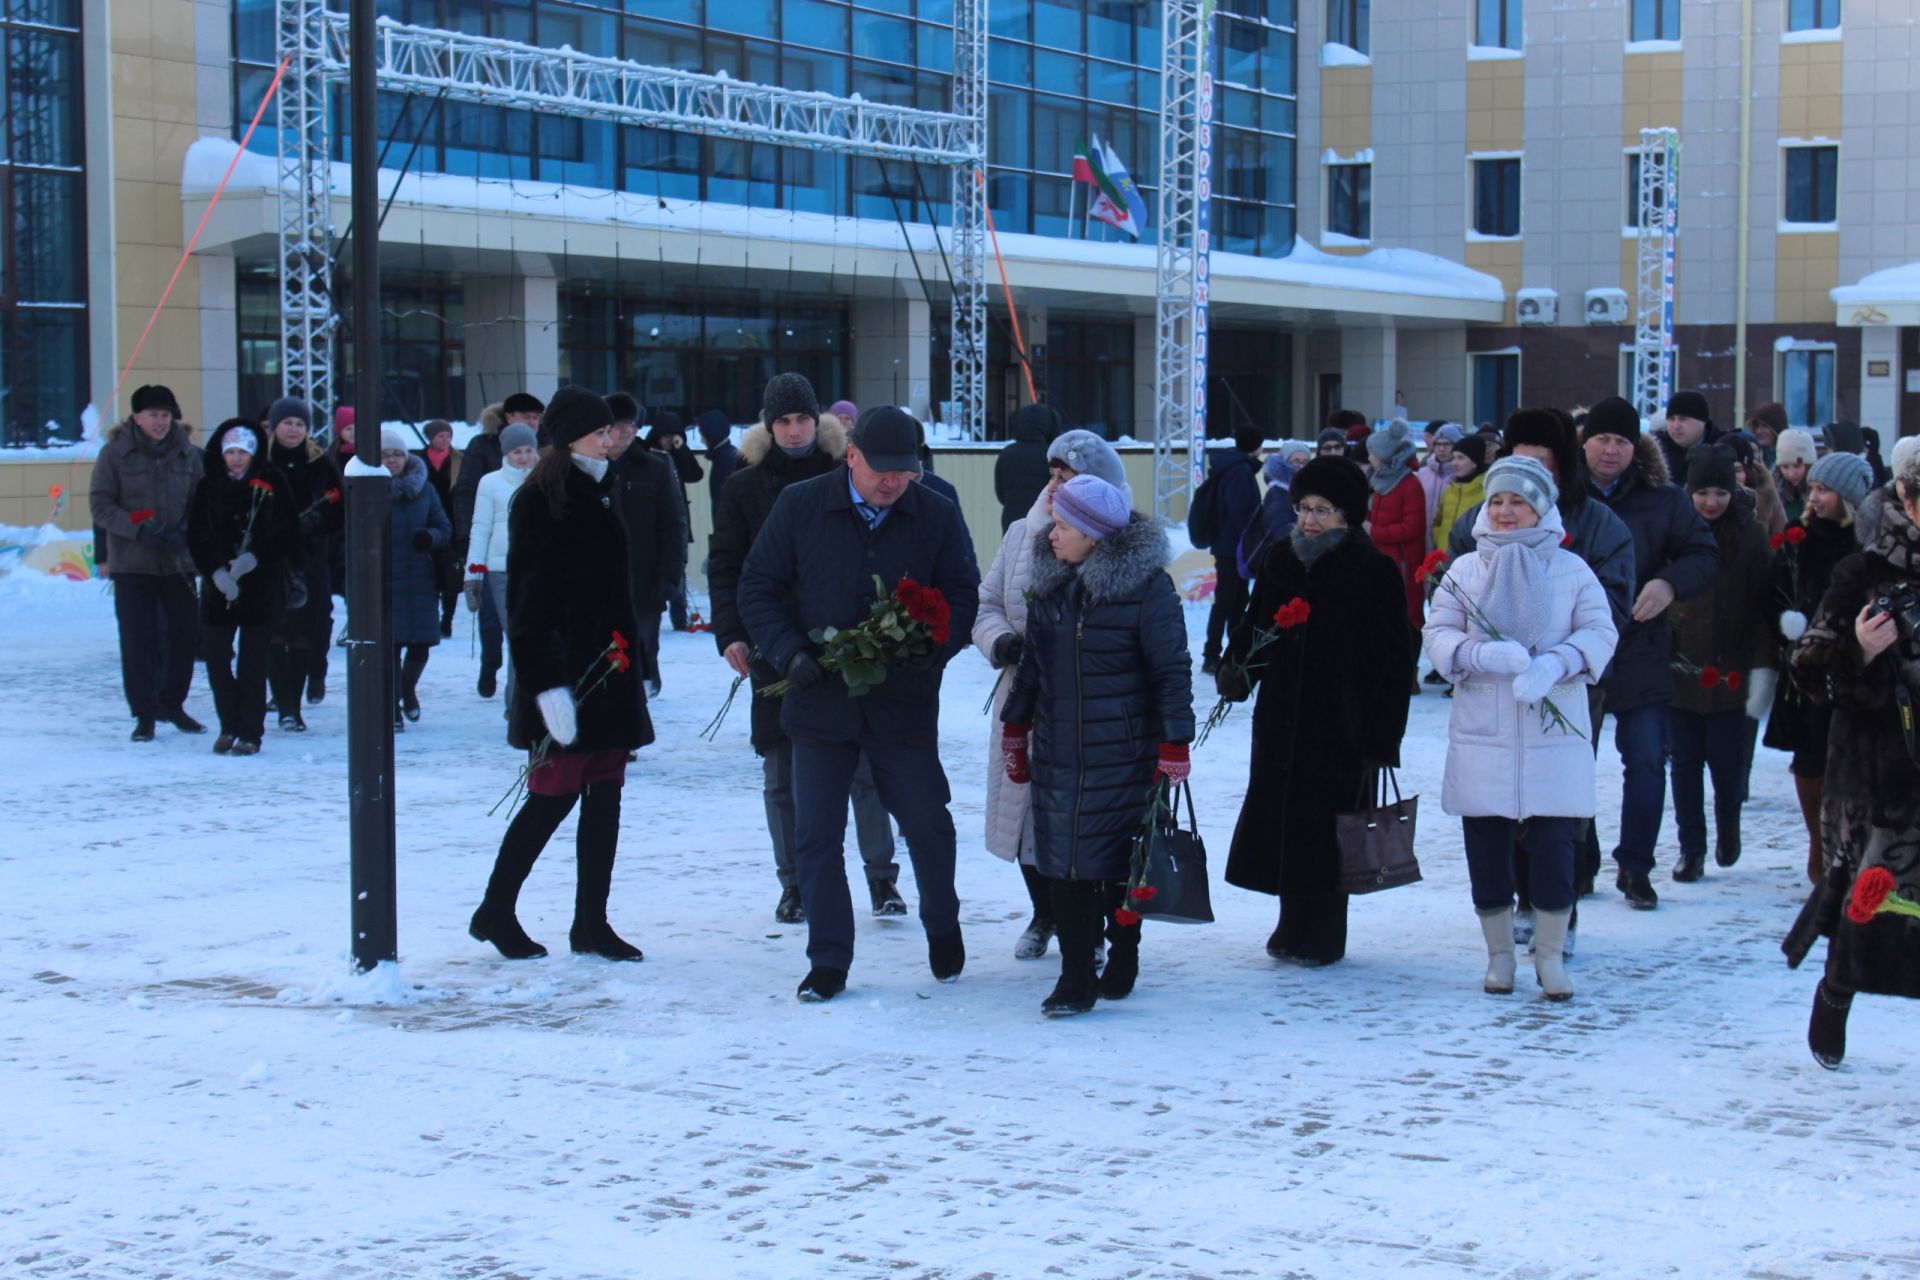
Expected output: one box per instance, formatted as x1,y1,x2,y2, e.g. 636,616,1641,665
1000,512,1194,881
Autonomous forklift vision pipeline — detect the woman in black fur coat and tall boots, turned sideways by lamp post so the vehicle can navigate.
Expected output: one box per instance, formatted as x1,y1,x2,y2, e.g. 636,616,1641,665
468,386,653,960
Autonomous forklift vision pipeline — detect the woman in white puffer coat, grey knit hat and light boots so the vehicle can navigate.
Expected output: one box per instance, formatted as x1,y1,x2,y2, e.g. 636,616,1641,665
1423,457,1620,1000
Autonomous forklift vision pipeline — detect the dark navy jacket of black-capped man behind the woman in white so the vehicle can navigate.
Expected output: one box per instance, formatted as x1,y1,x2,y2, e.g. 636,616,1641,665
1588,436,1720,712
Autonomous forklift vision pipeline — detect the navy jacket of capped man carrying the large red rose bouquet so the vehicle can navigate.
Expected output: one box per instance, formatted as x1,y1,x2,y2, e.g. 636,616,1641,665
735,466,979,745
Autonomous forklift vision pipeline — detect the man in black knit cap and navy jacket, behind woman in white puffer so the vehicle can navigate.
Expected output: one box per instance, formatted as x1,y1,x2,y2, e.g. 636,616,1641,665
1584,395,1720,912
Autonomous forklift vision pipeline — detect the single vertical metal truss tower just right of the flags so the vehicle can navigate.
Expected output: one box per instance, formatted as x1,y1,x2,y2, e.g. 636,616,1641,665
1154,0,1213,516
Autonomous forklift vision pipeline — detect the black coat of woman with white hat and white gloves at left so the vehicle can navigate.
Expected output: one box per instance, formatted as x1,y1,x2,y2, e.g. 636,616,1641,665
186,426,298,628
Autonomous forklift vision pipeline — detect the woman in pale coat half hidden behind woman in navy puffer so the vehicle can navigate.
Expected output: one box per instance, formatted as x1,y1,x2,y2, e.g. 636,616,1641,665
973,428,1133,960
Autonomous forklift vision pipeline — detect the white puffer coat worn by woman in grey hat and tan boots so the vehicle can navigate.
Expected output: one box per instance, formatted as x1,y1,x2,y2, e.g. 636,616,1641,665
1423,510,1620,818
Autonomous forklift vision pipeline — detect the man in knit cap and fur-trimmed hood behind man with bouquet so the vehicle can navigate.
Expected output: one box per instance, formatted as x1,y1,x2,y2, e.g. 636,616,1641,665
707,372,906,925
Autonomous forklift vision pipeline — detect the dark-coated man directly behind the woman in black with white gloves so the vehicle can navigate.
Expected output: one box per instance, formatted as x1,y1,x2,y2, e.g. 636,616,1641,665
607,401,687,697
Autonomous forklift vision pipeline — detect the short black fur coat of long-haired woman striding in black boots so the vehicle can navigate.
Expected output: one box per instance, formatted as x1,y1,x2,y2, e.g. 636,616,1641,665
507,464,653,752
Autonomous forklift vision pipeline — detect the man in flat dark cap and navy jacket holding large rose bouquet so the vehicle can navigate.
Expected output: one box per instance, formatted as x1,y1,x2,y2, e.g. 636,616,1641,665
737,407,979,1000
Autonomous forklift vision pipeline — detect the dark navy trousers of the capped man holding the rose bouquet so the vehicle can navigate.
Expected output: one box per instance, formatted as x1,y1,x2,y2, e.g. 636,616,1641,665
793,739,960,969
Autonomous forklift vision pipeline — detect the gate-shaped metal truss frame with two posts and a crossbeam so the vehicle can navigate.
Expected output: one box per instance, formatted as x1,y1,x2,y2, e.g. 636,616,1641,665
278,0,987,438
